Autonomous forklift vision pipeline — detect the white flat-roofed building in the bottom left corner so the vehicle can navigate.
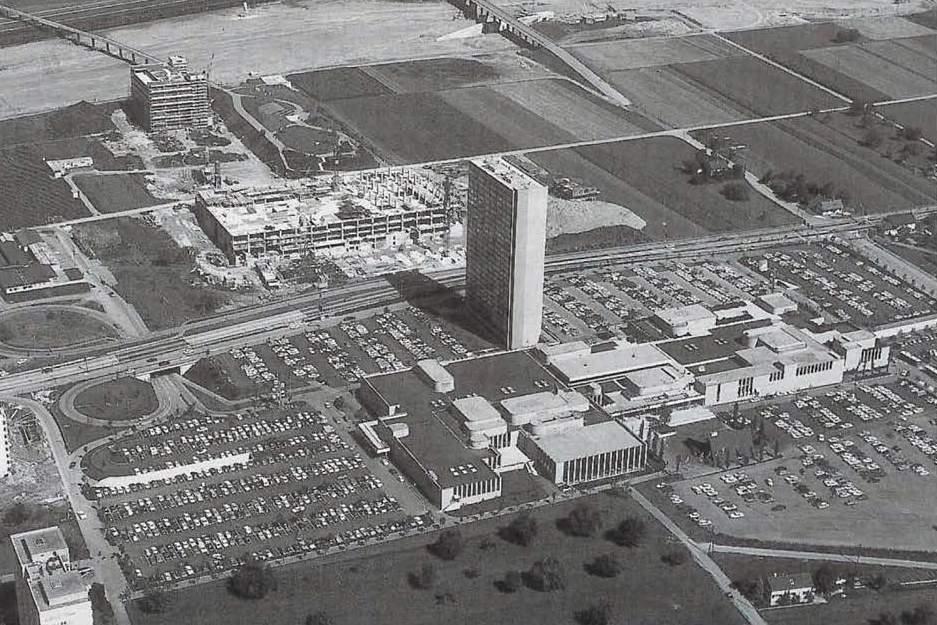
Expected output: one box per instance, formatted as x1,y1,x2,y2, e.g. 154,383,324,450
10,527,93,625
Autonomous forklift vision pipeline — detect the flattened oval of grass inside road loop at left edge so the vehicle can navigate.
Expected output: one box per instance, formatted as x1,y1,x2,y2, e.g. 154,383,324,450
0,308,117,349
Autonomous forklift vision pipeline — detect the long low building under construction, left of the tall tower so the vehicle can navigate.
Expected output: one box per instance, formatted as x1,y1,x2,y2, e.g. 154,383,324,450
195,170,449,264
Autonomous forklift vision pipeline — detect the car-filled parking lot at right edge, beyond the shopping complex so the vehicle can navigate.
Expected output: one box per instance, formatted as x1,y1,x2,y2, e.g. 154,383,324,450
741,241,937,327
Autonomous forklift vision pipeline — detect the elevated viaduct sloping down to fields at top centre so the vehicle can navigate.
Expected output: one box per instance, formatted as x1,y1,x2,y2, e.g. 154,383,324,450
449,0,631,106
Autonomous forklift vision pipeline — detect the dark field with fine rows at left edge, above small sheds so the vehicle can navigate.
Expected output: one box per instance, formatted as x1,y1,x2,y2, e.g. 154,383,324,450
0,142,89,232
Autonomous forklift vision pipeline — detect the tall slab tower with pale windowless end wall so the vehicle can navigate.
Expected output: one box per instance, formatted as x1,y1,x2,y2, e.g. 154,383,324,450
465,158,547,349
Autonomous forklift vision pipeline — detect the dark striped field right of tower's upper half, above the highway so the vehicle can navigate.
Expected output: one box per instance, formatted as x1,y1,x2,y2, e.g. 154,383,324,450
528,137,794,240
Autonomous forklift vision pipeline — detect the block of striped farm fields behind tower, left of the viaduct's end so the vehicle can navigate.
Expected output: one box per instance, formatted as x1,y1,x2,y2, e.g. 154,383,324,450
290,57,657,164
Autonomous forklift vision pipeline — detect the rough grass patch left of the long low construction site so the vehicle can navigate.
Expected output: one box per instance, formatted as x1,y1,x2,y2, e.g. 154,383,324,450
73,218,227,330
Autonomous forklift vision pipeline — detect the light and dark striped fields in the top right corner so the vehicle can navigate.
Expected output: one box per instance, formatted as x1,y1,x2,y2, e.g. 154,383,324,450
726,18,937,102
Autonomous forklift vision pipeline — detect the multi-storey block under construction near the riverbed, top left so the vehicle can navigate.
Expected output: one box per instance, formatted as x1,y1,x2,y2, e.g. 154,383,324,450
130,56,210,132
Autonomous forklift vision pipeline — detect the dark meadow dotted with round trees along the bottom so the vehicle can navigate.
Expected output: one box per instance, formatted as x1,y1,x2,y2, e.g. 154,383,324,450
131,494,744,625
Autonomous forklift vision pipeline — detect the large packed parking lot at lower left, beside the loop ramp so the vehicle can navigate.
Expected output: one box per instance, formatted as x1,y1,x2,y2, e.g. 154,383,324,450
86,406,427,587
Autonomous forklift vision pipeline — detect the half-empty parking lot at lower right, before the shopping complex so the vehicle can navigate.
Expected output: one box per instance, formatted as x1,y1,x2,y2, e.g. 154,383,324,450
659,379,937,550
